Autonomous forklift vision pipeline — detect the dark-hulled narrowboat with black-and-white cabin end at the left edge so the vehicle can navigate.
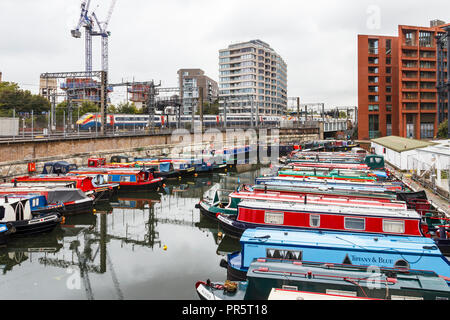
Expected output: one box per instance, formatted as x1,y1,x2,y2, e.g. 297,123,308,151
0,196,62,236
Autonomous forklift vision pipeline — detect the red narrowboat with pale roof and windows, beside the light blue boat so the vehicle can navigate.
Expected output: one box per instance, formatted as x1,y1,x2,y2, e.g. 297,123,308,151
217,196,428,238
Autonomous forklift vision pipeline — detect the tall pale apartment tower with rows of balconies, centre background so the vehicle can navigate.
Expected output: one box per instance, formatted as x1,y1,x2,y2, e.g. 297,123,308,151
219,40,288,115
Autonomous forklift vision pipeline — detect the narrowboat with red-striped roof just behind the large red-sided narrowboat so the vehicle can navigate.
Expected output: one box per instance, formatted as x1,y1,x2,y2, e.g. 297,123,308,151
196,185,407,219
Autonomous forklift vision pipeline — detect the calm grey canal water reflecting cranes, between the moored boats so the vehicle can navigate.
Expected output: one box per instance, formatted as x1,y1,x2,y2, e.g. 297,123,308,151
0,168,269,300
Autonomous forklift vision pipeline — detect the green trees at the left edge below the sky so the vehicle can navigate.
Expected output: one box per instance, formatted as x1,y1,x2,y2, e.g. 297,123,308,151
0,82,50,115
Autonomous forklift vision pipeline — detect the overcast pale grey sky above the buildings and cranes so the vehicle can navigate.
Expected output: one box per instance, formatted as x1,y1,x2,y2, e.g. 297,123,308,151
0,0,450,107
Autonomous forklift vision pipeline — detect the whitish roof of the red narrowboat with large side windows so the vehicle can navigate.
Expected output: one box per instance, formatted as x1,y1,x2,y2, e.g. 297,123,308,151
239,200,421,219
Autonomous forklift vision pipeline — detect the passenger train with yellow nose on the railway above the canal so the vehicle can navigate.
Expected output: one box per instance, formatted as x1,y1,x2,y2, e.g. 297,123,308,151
76,113,294,130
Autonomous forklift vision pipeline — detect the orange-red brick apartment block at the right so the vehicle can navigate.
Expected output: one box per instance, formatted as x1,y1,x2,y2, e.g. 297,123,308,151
358,20,447,139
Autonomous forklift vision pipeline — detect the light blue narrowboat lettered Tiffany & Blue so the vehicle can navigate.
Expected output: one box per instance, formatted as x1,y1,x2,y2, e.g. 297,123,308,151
225,228,450,284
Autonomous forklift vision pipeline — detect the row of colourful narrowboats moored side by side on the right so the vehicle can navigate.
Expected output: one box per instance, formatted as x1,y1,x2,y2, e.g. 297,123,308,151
195,144,450,300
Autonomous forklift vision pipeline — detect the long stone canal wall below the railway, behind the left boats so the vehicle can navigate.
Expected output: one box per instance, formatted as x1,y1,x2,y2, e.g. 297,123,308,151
0,129,320,180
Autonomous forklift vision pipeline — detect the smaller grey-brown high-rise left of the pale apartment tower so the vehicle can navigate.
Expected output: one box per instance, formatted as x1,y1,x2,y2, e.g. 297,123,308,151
178,69,219,114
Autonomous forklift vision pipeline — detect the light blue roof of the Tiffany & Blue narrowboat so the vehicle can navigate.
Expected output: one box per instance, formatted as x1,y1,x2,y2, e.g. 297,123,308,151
240,228,442,256
